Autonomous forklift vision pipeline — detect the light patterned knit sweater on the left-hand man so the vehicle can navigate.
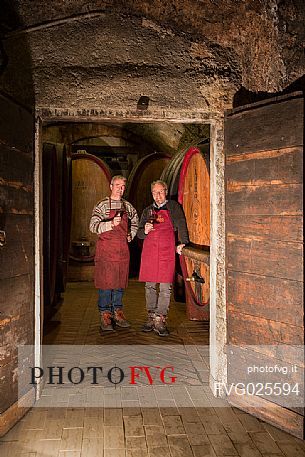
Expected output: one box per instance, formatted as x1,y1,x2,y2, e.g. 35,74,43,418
89,197,139,239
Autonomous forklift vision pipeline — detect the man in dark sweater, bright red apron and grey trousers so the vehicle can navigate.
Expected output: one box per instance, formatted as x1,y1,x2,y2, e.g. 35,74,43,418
137,180,189,336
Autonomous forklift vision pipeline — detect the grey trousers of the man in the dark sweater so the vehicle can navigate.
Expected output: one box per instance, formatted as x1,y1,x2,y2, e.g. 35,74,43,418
145,282,172,316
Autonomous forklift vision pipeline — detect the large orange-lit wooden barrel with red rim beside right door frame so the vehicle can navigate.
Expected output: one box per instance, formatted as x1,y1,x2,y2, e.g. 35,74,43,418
178,147,210,320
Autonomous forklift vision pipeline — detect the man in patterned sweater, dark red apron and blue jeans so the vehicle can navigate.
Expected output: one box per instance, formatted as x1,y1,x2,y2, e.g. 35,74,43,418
89,175,139,331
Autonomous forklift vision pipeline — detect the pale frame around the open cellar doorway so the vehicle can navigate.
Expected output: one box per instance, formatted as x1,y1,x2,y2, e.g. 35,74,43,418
34,107,227,397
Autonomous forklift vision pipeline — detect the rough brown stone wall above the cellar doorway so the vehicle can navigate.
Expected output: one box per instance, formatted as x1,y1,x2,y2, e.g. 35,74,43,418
3,0,305,112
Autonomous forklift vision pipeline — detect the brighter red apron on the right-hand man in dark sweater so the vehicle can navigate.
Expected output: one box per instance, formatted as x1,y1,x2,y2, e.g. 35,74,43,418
139,209,175,283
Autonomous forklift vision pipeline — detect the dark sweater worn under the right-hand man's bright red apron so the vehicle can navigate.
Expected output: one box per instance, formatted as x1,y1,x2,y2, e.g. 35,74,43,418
137,200,189,244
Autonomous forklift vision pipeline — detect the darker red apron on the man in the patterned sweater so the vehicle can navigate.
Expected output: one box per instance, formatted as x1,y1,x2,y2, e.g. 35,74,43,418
94,201,129,290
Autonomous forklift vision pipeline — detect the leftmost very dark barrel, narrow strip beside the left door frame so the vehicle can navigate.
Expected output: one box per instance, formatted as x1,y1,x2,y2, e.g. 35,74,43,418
42,143,58,319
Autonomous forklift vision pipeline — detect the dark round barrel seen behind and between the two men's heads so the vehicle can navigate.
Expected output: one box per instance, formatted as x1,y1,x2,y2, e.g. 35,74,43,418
126,152,170,217
